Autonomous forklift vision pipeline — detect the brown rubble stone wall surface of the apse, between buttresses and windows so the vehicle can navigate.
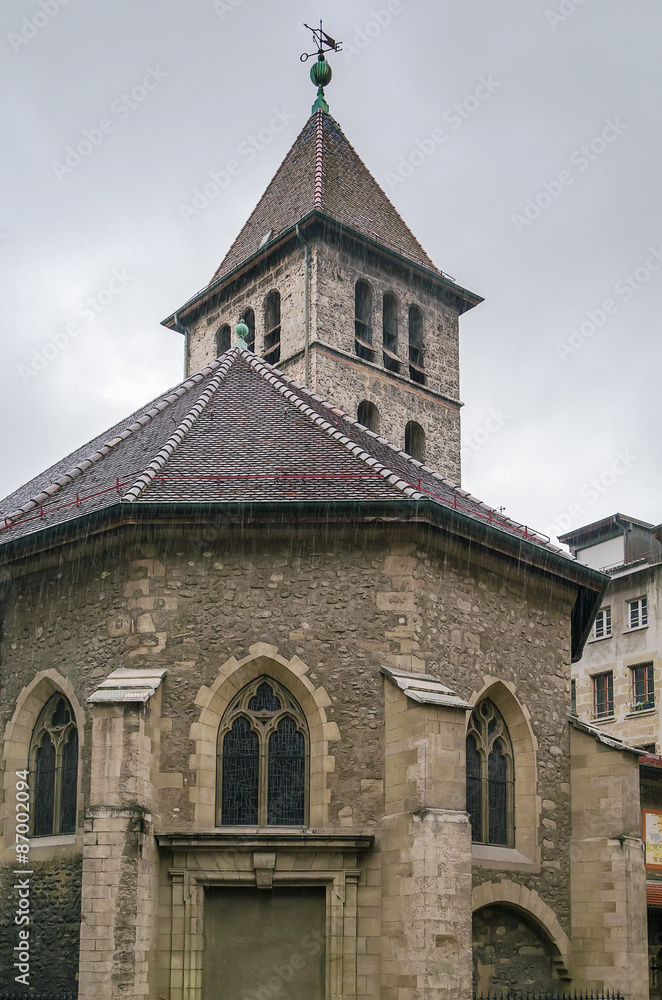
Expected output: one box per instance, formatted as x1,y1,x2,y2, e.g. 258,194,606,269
0,525,588,997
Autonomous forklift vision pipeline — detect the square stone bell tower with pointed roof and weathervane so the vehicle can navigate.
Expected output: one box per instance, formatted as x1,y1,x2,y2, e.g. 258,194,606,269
164,52,482,483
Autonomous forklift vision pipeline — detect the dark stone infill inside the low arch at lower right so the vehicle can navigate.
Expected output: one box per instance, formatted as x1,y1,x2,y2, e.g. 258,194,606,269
473,906,559,996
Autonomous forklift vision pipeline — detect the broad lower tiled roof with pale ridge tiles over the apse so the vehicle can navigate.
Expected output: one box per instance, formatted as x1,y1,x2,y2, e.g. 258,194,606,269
0,347,565,554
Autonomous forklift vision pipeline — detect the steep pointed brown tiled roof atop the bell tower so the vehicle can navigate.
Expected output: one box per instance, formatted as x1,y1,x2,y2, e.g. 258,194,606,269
212,111,441,282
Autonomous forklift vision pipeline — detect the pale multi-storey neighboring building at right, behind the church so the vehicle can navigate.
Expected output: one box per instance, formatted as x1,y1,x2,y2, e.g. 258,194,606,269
559,514,662,995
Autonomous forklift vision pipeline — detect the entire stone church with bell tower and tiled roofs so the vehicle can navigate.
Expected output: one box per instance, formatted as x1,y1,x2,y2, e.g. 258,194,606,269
0,34,649,1000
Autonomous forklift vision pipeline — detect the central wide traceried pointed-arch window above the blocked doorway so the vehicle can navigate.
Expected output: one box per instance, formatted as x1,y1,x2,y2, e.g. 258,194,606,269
216,677,309,826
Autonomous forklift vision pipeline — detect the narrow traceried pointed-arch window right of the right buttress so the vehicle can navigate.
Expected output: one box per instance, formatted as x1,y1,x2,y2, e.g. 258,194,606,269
467,698,515,847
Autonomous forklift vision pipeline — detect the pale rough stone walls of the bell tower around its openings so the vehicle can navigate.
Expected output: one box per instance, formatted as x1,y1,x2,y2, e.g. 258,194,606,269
188,240,462,483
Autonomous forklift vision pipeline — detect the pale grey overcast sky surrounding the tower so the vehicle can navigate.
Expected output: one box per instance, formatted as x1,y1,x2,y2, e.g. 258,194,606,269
0,0,662,548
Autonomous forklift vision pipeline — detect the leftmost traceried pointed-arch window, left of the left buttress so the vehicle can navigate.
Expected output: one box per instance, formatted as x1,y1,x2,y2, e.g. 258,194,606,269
30,694,78,837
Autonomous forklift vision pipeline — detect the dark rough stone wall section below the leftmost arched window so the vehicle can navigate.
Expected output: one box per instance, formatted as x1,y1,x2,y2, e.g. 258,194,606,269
0,857,81,993
